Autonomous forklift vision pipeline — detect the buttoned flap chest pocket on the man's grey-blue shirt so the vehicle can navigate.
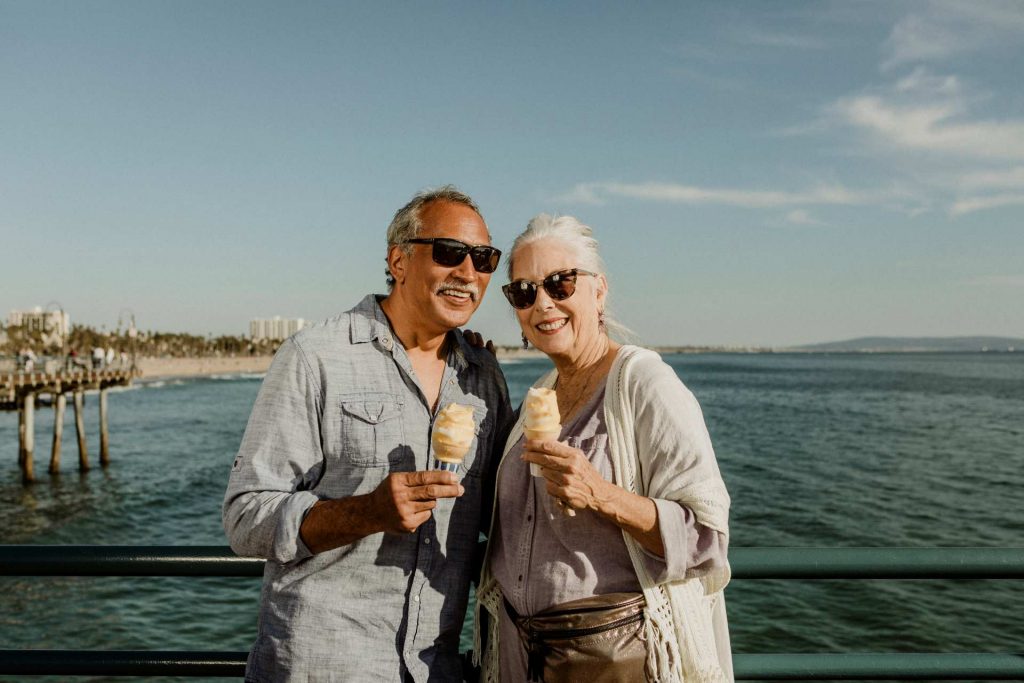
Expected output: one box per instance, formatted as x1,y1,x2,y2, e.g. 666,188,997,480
340,393,406,467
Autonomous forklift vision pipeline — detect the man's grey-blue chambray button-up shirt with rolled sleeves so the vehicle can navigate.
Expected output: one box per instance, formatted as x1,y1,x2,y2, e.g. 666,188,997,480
223,295,511,682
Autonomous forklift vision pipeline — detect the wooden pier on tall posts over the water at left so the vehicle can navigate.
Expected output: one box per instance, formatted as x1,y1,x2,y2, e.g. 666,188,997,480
0,368,141,482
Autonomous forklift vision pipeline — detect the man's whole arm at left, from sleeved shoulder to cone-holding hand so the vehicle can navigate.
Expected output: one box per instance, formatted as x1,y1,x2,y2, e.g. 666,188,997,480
223,340,463,563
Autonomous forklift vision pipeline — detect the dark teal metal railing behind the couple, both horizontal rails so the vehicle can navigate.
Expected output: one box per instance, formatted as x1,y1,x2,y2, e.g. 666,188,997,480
0,546,1024,681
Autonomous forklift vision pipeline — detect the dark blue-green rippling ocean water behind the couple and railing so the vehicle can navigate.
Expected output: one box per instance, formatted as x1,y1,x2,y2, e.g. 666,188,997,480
0,353,1024,681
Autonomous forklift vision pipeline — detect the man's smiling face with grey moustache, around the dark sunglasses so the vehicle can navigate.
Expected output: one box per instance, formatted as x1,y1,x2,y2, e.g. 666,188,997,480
396,200,490,332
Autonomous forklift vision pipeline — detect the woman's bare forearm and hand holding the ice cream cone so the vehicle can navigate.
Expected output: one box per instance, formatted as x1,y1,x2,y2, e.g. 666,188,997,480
522,439,665,557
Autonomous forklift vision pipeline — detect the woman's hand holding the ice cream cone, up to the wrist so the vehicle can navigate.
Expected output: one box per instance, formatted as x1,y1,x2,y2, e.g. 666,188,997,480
522,439,618,513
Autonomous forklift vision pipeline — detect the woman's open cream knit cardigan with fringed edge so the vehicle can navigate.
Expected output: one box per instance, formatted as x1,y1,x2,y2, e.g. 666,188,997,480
473,346,733,683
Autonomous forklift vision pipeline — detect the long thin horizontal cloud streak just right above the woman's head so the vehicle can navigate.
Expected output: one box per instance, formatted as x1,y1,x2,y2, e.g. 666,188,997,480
559,182,867,209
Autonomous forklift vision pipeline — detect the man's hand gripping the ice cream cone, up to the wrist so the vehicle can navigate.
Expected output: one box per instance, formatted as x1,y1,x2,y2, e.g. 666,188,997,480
370,470,466,533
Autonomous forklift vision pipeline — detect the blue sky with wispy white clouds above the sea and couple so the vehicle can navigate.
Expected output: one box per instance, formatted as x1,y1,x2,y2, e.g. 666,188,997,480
0,0,1024,346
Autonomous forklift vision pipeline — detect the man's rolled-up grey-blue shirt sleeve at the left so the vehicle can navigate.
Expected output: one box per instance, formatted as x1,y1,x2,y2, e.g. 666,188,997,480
222,340,324,563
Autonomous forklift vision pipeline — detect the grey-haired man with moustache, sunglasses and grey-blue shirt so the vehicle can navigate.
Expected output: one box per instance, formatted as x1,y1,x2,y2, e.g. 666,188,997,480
223,186,511,682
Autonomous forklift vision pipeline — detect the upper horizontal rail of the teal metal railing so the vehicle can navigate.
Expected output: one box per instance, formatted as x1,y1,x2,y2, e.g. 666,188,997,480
0,545,1024,580
